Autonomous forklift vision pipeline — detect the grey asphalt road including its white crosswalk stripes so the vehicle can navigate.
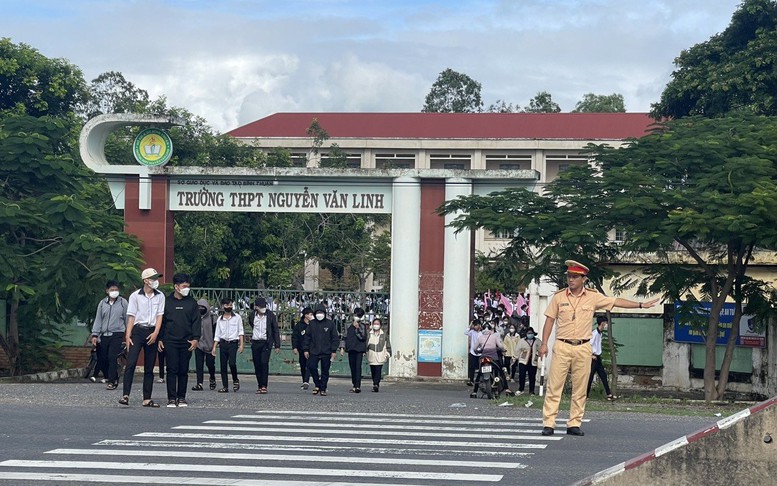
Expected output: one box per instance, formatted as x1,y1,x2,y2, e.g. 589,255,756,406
0,375,716,486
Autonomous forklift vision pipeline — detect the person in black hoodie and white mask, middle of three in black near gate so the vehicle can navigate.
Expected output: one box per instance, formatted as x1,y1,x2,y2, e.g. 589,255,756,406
302,304,340,397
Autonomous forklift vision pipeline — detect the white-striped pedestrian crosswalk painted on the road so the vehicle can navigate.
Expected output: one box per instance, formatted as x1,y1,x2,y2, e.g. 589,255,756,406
0,410,564,486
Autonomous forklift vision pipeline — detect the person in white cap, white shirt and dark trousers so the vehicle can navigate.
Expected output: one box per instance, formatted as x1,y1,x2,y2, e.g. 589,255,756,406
119,268,165,408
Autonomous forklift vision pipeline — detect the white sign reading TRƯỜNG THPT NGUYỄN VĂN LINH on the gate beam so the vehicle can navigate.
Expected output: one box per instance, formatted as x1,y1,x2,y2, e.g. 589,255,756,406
169,178,392,214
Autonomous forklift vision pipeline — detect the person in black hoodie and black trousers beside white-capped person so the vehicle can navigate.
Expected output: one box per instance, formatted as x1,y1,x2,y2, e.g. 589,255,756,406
159,273,201,407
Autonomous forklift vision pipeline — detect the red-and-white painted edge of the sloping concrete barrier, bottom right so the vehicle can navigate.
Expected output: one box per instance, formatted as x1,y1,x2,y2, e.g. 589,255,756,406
573,397,777,486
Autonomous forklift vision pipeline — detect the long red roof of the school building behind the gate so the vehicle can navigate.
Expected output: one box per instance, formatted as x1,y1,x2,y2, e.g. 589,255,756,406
228,113,653,140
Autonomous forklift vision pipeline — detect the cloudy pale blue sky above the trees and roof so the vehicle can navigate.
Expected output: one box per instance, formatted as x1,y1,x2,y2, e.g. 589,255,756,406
0,0,740,132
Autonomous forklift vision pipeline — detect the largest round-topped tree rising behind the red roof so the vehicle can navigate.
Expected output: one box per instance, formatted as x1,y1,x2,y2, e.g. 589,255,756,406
421,68,483,113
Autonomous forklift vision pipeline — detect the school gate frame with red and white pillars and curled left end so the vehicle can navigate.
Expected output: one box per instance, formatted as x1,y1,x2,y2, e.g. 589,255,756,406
79,114,538,379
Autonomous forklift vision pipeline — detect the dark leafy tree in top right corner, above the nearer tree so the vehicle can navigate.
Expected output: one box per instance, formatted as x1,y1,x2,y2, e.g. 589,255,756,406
651,0,777,119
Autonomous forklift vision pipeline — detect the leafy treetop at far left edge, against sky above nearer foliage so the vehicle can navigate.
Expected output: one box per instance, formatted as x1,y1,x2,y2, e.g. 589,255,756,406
0,38,86,117
